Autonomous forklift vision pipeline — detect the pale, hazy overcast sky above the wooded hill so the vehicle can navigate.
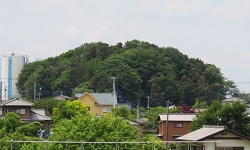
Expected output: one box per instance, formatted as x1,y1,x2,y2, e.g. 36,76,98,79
0,0,250,93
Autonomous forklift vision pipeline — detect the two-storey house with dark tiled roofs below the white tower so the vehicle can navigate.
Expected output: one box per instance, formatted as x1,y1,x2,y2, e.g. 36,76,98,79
0,98,52,136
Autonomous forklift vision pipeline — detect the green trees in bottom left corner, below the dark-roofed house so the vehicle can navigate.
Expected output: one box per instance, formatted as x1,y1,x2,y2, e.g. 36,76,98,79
0,112,44,150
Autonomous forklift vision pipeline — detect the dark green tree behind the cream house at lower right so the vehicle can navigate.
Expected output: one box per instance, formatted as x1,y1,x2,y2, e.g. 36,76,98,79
190,101,250,136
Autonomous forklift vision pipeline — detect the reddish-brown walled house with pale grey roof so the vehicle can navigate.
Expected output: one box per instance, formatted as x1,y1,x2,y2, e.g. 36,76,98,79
157,114,196,141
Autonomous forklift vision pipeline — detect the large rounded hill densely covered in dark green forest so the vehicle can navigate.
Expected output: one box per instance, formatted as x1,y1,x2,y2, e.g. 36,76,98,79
17,40,235,106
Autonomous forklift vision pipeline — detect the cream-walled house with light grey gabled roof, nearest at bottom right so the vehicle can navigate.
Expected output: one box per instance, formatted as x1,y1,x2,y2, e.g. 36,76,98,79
177,126,250,150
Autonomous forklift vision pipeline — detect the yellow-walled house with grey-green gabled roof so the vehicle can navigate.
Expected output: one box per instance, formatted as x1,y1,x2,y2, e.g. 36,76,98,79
78,92,117,116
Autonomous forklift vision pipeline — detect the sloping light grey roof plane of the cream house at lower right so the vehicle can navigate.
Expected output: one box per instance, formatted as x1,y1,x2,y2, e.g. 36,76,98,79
177,126,225,141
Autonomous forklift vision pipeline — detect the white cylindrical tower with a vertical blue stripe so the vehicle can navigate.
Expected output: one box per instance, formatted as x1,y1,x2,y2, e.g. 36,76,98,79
0,53,28,100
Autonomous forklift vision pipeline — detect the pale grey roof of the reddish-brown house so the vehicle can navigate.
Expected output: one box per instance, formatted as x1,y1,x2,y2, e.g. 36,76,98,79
159,114,196,121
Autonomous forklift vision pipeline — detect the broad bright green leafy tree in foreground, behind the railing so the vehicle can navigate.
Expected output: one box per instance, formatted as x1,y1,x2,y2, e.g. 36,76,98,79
50,115,138,150
